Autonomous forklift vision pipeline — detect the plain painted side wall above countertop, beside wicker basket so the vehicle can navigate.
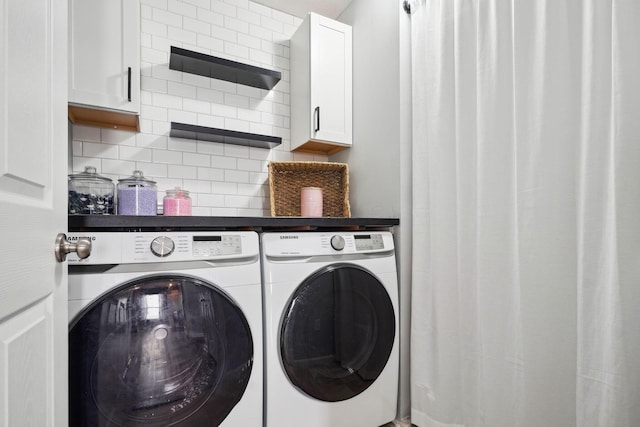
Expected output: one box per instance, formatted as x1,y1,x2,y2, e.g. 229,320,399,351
330,0,400,217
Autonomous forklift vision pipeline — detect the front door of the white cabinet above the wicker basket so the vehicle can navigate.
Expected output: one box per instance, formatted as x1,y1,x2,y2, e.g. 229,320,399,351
310,14,352,144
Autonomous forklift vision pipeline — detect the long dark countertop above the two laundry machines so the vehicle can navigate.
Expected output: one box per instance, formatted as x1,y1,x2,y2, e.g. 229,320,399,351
69,215,400,232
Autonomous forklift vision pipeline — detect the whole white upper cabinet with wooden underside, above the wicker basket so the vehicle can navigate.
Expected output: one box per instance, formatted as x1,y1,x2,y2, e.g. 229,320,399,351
291,13,352,155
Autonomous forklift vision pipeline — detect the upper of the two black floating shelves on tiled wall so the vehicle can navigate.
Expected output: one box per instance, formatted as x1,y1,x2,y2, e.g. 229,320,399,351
169,46,282,90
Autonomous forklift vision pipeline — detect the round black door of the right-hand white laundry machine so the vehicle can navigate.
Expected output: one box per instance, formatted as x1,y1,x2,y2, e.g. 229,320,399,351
280,264,395,402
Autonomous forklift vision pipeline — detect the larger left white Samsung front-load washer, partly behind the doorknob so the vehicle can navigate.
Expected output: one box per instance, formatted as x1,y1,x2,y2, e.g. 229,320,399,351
68,232,263,427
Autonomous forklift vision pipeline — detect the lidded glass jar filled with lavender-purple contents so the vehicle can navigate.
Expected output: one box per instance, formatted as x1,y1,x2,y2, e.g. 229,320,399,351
117,171,158,215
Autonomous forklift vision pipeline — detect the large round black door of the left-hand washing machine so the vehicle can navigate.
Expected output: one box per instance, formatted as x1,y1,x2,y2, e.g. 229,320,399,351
69,275,253,427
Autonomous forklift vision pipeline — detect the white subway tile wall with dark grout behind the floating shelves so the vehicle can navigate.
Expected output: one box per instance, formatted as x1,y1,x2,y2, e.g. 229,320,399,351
72,0,327,216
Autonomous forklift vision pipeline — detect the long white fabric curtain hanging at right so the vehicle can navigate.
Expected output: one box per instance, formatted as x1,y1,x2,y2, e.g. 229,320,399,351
411,0,640,427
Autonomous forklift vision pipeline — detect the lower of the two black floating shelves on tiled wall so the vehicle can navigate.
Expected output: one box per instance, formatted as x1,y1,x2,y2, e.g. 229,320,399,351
169,122,282,148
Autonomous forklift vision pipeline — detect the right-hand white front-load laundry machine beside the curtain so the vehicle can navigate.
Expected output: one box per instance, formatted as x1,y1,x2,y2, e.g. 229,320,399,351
261,232,399,427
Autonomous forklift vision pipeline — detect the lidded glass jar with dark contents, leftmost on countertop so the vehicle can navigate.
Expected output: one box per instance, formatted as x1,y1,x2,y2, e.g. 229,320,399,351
69,166,114,215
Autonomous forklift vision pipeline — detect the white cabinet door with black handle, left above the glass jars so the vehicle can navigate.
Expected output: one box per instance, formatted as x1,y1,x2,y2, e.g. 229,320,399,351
69,0,140,113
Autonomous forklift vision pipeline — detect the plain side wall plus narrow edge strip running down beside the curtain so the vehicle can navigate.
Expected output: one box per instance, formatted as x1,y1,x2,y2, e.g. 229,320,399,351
330,0,411,419
